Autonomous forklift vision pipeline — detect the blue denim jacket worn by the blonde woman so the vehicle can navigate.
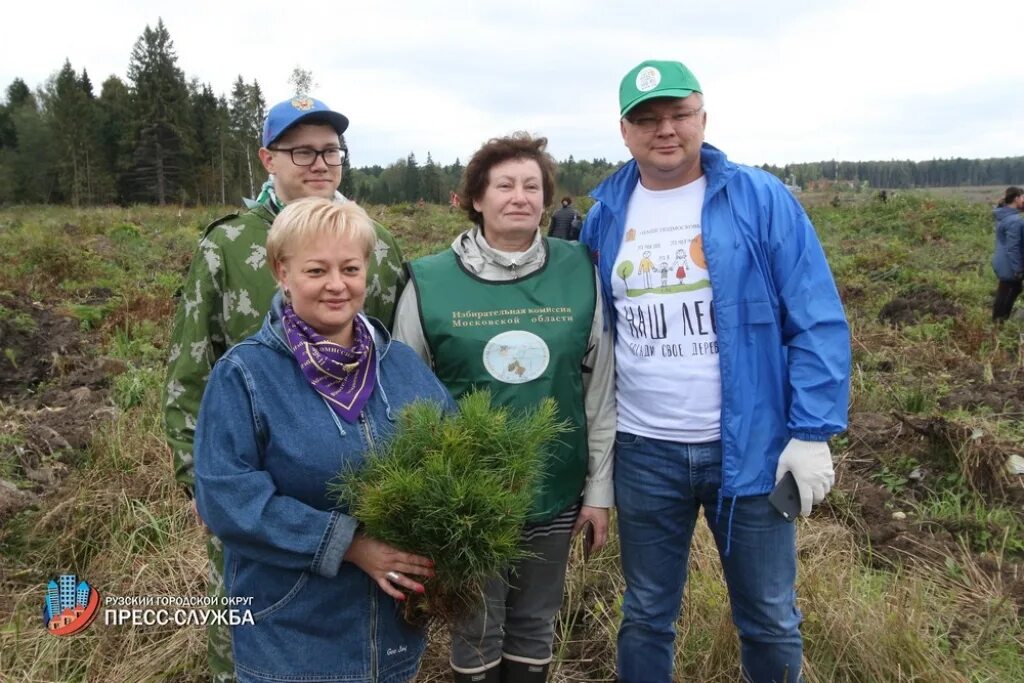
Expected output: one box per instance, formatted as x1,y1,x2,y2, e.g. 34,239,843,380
196,294,454,683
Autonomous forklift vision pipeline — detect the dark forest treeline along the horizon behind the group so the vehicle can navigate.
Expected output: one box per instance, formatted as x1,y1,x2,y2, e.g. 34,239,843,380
0,20,1024,206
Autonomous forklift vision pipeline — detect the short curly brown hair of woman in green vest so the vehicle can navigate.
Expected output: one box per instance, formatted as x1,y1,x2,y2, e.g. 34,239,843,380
459,131,555,227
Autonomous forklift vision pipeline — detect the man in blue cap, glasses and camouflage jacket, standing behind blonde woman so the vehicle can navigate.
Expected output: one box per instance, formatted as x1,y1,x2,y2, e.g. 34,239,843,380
164,97,404,683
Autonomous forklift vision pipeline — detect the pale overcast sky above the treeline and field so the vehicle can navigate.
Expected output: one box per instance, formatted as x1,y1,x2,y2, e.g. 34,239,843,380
0,0,1024,166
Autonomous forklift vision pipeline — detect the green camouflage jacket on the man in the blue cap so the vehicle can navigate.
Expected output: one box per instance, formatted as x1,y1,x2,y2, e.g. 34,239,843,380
164,197,406,490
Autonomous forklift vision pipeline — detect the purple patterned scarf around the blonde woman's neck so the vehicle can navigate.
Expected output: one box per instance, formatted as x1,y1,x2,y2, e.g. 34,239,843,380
282,304,377,423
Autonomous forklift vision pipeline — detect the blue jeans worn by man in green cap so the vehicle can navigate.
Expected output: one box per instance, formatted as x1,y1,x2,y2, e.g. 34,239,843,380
614,432,803,683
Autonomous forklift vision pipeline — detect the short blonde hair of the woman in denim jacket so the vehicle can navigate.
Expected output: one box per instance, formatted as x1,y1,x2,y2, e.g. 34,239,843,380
266,197,377,268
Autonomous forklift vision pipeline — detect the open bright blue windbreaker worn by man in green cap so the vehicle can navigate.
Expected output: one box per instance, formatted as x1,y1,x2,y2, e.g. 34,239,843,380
580,143,850,500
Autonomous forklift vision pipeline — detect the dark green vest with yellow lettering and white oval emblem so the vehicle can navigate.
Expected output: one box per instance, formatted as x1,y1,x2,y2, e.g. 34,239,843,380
410,239,595,522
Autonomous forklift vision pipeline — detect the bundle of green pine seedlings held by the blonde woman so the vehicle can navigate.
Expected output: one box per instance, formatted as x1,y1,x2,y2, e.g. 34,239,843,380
333,390,568,624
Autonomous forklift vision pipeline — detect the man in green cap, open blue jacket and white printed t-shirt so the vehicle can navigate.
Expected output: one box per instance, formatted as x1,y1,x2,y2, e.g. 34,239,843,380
581,60,850,683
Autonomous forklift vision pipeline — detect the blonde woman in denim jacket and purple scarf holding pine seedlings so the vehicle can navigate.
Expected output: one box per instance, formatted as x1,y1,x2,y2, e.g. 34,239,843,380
196,198,453,682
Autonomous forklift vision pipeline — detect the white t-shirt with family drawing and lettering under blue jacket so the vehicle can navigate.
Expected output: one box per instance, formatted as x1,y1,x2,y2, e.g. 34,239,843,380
611,176,722,443
